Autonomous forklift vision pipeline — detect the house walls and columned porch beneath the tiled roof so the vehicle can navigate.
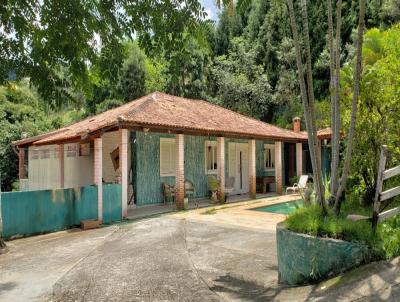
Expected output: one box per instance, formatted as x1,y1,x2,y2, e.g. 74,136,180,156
14,129,303,221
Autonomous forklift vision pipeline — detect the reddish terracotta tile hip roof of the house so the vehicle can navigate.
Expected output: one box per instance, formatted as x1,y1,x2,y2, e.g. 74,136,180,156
14,92,307,145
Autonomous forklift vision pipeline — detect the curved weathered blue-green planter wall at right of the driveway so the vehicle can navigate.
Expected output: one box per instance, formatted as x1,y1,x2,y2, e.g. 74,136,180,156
276,222,371,285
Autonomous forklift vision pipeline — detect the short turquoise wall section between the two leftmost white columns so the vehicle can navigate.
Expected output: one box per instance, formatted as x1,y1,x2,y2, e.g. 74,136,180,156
103,184,122,224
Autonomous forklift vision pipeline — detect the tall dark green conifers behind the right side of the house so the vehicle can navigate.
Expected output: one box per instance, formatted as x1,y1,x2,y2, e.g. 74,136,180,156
209,0,400,127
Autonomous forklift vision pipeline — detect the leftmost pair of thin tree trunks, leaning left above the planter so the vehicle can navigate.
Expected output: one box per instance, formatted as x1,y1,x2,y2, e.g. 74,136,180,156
287,0,327,215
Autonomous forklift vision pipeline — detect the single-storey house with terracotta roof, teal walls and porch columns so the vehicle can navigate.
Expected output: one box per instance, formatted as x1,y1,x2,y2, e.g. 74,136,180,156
13,92,332,220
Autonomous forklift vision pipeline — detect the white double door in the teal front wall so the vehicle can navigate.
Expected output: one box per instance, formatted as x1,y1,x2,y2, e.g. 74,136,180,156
228,143,249,194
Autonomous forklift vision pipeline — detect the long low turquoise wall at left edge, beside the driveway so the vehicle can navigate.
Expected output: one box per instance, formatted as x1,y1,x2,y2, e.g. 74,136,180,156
1,186,97,238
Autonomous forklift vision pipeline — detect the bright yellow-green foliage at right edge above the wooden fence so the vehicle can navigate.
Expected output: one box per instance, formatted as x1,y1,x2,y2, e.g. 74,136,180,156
342,25,400,204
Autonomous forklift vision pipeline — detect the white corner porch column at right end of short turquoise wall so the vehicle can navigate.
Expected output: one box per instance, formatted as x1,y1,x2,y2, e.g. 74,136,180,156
119,129,129,218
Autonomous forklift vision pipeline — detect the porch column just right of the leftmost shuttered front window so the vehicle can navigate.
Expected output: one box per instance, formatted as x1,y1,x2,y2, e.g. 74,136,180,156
175,134,185,210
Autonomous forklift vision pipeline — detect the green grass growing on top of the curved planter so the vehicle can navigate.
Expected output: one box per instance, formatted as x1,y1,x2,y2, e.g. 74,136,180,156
285,203,400,259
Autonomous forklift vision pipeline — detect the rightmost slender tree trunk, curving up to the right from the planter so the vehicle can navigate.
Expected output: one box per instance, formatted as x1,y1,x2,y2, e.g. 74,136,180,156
335,0,366,214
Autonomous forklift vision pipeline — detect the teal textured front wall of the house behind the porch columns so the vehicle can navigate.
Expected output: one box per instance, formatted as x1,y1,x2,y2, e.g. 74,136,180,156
133,132,284,206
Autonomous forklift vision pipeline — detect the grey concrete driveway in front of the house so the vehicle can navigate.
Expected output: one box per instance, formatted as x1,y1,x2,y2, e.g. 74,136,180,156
0,196,400,301
